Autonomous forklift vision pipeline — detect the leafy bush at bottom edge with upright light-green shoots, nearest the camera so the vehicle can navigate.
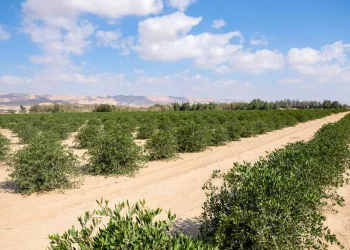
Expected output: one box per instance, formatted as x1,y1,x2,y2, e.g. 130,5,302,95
49,200,217,250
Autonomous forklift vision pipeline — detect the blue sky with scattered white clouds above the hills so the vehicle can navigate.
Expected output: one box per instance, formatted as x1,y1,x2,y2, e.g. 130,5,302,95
0,0,350,103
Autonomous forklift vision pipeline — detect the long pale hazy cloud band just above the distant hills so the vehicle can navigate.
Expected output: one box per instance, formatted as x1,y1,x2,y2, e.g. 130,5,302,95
0,70,255,99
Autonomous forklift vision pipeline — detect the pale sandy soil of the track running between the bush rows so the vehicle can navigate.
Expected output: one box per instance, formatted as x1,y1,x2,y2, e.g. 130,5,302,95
0,114,350,250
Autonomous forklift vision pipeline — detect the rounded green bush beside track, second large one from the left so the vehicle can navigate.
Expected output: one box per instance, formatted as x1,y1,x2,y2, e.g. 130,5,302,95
88,131,145,175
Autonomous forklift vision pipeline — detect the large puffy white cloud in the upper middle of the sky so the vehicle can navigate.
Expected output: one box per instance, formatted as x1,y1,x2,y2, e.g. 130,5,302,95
134,12,284,73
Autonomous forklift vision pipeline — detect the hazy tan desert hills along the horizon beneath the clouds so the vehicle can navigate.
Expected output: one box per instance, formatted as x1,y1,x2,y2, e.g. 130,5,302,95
0,93,242,107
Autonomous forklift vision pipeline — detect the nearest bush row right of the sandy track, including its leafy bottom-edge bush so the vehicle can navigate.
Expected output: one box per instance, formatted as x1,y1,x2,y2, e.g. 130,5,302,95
49,115,350,250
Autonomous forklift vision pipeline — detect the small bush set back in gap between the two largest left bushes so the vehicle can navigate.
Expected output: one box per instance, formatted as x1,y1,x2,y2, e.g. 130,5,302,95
74,125,102,148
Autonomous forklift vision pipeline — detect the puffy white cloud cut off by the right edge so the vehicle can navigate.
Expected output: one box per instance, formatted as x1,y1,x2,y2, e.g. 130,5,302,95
287,41,350,82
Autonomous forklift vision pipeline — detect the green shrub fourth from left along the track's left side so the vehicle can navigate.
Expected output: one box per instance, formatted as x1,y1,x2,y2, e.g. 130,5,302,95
177,122,210,152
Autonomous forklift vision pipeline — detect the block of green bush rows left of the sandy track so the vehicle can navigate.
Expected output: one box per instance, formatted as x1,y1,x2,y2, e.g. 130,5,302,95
0,110,339,193
